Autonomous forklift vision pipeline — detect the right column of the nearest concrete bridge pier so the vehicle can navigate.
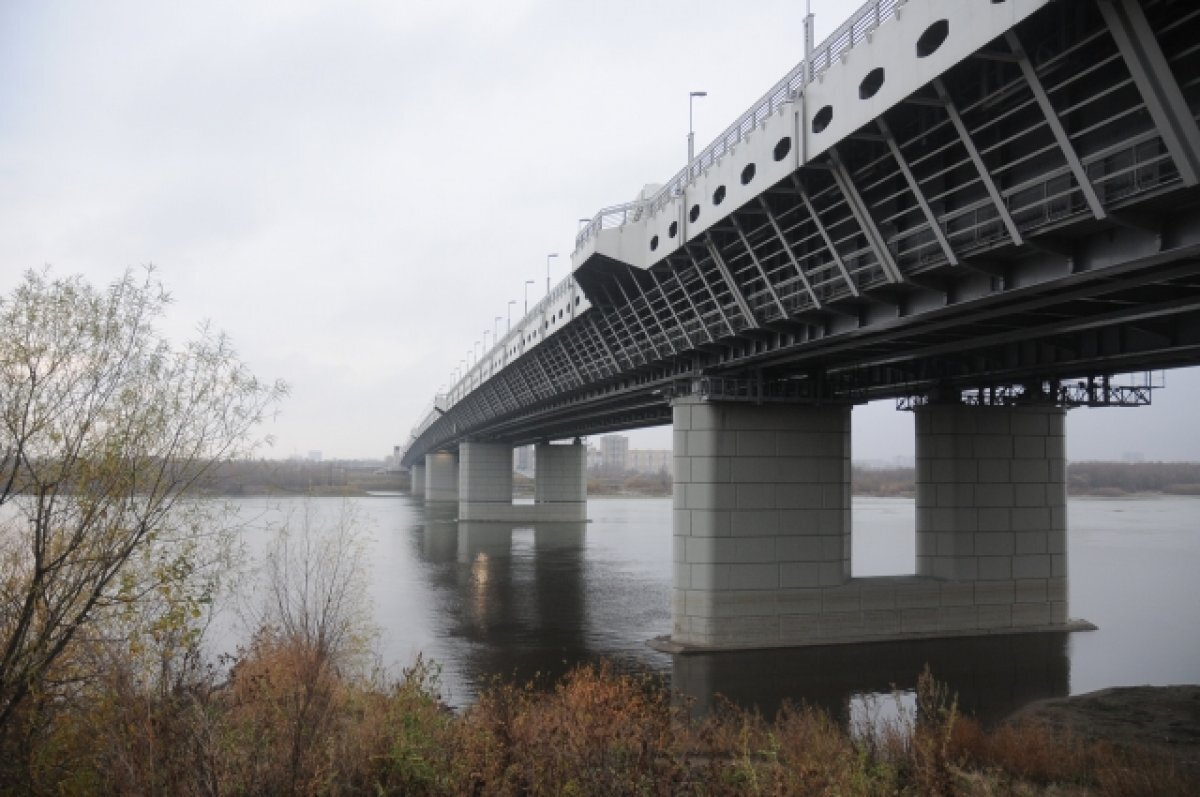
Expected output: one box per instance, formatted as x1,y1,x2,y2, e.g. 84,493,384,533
917,405,1067,633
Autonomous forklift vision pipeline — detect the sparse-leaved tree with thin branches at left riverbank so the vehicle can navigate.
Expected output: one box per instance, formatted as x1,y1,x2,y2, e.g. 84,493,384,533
0,269,286,742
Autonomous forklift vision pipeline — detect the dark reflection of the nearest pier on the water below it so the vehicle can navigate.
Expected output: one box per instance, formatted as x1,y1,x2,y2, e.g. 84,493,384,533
671,633,1070,723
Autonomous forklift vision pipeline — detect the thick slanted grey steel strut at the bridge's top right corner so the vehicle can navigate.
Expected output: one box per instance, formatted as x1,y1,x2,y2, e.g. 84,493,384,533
1096,0,1200,186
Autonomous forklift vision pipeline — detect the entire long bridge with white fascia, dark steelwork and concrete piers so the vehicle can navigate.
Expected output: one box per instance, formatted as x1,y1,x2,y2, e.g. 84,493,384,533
402,0,1200,648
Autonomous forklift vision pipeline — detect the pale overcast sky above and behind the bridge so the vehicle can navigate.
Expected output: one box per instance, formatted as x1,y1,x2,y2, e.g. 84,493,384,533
0,0,1200,459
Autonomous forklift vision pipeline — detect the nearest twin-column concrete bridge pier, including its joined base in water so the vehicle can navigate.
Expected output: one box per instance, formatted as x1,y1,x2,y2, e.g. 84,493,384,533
666,397,1090,651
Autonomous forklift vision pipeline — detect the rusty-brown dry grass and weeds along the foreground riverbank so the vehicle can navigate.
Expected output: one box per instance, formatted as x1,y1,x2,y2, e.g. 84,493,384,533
0,652,1200,796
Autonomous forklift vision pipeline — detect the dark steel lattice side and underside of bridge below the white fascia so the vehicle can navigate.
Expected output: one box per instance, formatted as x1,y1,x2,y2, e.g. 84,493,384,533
409,0,1200,456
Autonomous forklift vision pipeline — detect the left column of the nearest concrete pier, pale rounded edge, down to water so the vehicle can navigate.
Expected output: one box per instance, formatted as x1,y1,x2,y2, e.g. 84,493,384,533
667,399,863,647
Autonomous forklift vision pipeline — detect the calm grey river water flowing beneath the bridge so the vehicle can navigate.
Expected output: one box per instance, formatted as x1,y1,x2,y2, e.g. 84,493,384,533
222,496,1200,719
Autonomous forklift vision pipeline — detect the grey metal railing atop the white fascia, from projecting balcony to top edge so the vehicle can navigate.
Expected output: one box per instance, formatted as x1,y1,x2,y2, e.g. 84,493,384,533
575,0,908,250
